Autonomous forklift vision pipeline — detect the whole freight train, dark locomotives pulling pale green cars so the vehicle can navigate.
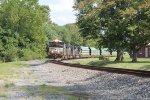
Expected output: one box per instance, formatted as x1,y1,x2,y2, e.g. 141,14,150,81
47,39,116,59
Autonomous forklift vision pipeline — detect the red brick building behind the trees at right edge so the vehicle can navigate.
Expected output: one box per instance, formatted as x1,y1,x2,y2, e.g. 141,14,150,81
137,43,150,58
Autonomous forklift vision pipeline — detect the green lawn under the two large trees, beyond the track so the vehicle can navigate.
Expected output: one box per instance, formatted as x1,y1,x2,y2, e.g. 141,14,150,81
71,57,150,71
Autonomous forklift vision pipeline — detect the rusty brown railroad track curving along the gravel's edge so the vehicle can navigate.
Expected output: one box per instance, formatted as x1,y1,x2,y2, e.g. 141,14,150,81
50,60,150,77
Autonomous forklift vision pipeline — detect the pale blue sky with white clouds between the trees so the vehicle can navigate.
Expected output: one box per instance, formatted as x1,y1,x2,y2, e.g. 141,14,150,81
39,0,76,25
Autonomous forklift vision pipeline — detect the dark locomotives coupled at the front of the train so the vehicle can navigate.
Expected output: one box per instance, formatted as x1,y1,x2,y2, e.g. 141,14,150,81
47,39,81,59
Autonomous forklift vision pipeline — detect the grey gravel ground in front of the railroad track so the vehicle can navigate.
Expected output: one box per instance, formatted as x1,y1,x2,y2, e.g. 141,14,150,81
0,60,150,100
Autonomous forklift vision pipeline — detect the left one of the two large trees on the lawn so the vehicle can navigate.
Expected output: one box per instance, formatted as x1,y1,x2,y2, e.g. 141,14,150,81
75,0,125,61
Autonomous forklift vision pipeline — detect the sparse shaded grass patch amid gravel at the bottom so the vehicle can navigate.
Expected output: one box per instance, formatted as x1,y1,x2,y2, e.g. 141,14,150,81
21,84,84,100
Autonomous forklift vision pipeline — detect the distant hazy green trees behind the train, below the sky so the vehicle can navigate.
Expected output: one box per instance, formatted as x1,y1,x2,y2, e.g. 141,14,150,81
46,23,96,47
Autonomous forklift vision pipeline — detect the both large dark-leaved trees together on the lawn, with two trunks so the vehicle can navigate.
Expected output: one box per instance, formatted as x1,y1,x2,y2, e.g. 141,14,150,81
74,0,150,62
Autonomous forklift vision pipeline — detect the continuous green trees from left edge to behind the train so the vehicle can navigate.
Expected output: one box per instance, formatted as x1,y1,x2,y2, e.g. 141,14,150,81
0,0,96,61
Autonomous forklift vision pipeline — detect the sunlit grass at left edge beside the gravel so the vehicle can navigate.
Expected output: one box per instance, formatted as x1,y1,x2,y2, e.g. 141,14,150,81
0,62,27,98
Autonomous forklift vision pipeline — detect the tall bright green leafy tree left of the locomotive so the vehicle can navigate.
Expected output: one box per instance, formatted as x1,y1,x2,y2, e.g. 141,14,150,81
0,0,50,60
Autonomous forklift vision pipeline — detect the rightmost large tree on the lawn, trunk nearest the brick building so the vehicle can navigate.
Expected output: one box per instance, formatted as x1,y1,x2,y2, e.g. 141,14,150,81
121,0,150,62
